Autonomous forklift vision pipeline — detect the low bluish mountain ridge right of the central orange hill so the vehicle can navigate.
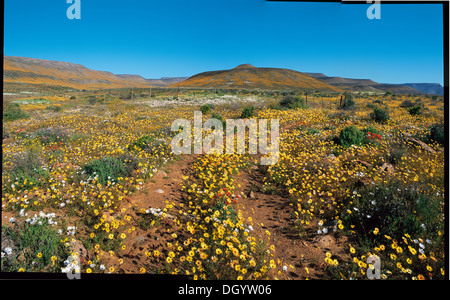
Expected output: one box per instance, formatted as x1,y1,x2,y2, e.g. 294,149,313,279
305,73,430,95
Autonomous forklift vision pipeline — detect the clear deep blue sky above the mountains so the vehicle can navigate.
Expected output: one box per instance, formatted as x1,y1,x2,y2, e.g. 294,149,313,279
4,0,443,84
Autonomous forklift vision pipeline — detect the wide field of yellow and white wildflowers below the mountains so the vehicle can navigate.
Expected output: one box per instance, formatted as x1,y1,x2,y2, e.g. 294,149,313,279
1,88,447,280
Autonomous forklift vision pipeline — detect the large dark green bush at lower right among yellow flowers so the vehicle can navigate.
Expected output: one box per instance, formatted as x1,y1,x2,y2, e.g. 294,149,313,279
342,180,443,240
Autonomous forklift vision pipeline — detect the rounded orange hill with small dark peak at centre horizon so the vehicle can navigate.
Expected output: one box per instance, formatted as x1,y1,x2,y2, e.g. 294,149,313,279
170,64,341,92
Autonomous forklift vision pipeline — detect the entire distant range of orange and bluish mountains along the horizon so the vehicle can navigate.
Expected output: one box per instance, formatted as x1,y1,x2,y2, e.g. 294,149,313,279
3,56,443,95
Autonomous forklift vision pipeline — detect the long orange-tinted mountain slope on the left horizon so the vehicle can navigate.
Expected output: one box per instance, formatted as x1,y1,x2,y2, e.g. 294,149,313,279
3,56,187,89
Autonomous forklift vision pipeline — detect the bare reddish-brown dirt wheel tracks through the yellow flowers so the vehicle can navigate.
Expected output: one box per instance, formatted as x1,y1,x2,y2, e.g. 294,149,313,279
110,126,350,279
